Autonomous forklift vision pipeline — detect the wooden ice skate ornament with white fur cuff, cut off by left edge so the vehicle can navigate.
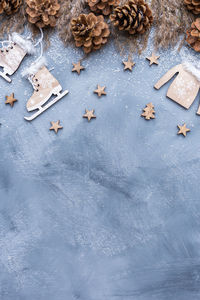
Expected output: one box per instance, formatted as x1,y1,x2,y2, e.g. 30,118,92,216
0,33,34,82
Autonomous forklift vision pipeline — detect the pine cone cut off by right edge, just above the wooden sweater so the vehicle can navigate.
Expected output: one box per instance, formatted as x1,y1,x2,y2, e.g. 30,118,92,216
186,18,200,52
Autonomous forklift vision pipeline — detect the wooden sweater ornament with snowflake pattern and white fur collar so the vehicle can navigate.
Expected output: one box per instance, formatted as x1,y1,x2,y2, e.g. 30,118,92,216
154,63,200,115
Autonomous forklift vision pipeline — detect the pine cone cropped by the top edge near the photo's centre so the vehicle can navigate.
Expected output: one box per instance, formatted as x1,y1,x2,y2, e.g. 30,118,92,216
88,0,119,16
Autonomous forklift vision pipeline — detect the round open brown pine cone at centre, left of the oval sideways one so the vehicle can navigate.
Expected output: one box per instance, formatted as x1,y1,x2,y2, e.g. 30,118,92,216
71,13,110,53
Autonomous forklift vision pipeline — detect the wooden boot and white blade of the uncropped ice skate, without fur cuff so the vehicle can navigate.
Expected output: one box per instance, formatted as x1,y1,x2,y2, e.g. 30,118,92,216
24,66,68,121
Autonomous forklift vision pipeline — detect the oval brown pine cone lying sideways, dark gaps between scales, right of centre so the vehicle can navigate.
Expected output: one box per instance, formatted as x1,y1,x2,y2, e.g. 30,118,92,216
110,0,153,34
